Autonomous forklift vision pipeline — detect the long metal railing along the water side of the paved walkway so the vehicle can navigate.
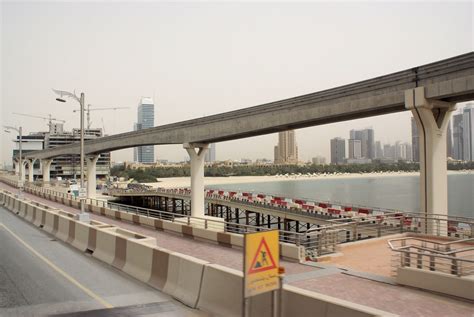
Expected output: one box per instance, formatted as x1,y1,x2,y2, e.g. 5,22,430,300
1,173,474,257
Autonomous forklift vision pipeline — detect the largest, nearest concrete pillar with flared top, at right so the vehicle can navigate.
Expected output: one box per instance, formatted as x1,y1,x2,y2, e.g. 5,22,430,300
405,87,455,235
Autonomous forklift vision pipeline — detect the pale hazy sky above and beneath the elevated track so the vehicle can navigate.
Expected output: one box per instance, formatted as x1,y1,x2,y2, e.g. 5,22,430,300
0,1,474,162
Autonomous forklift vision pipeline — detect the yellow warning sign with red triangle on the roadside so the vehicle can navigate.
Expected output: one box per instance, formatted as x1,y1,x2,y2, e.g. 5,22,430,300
244,230,280,298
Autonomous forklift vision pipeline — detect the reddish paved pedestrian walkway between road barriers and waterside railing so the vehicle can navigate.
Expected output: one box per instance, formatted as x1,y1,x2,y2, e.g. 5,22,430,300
0,183,474,317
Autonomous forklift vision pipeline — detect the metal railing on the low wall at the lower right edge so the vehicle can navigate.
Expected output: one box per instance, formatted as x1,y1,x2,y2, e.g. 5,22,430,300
388,237,474,277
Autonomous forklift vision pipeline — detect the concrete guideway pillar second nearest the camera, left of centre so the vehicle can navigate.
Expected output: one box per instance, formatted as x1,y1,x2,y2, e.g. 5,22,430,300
183,143,209,217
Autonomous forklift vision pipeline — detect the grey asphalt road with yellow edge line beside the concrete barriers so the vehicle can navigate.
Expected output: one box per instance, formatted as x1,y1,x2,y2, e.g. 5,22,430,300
0,207,202,316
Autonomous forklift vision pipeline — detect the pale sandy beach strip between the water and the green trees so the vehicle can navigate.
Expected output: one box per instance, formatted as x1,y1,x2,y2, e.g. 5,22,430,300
143,171,474,188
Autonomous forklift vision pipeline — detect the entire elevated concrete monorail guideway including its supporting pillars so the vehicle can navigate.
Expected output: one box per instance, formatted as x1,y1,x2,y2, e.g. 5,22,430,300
20,52,474,233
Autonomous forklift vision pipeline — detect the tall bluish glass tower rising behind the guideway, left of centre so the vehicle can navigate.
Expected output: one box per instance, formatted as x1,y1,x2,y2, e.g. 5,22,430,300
134,97,155,163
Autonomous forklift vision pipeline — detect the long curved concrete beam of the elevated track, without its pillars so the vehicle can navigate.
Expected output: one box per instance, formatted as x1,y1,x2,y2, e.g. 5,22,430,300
27,53,474,159
